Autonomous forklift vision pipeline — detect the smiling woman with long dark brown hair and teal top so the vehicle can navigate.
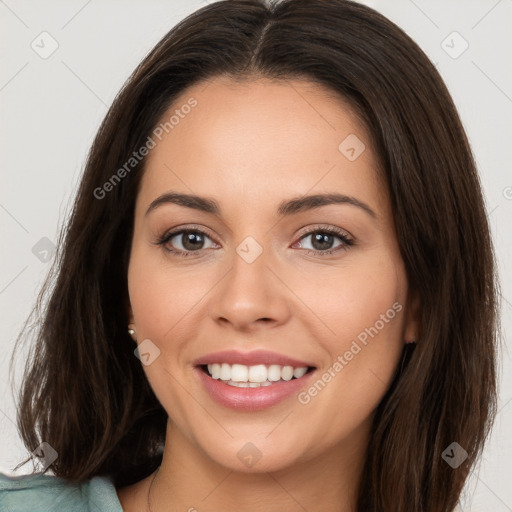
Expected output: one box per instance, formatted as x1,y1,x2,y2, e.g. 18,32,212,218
0,0,498,512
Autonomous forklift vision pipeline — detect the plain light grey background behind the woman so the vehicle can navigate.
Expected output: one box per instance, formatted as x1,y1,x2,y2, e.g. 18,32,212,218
0,0,512,512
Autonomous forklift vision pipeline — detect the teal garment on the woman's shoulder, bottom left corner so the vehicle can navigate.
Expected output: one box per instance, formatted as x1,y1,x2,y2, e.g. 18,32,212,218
0,472,123,512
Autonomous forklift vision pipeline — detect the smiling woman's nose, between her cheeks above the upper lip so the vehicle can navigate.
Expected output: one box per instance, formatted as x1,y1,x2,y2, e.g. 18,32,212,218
209,243,290,332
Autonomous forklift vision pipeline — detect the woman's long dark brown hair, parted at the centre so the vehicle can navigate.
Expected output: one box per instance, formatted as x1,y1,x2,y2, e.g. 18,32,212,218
8,0,499,512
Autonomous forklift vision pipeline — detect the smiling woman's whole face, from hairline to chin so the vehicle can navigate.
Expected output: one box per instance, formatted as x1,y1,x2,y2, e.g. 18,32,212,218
127,75,417,471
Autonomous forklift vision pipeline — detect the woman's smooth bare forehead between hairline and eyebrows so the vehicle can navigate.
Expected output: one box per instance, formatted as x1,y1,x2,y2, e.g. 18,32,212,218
139,77,386,218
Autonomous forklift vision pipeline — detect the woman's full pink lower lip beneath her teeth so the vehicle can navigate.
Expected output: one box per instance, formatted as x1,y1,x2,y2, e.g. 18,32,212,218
195,367,315,411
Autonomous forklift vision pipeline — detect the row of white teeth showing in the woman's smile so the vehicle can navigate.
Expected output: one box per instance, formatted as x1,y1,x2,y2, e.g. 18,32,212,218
207,363,308,387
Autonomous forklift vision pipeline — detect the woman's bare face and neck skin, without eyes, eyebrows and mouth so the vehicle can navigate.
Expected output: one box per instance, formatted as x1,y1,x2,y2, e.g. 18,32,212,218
118,78,419,512
